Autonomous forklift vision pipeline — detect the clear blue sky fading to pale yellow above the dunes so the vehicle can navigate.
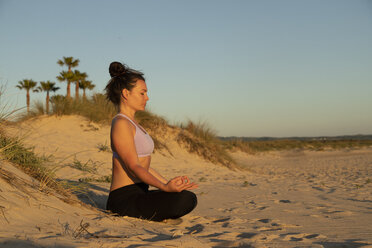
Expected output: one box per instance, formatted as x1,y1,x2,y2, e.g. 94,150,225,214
0,0,372,137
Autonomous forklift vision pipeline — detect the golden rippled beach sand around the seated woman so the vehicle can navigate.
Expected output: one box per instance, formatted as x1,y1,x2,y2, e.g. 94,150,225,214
0,116,372,247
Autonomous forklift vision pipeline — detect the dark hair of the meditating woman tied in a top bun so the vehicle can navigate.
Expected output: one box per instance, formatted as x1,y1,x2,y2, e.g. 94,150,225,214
105,62,145,105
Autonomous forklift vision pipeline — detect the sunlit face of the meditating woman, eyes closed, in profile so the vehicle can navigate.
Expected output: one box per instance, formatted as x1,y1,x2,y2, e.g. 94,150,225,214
123,80,149,111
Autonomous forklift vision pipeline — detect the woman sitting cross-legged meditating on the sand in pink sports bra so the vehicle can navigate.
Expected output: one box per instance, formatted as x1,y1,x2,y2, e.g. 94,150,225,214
105,62,197,221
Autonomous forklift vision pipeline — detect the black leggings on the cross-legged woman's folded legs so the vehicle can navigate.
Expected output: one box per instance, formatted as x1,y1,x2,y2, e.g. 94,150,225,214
106,183,197,221
